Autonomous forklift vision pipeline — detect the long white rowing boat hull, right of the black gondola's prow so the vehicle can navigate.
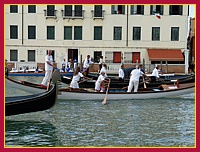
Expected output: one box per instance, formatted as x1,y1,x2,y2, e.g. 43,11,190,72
58,83,195,100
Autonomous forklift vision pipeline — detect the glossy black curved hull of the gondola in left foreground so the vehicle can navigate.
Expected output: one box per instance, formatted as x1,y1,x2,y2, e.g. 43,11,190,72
5,82,57,116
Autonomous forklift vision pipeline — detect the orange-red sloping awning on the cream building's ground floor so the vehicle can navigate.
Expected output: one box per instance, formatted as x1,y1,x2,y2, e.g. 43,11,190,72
147,49,184,61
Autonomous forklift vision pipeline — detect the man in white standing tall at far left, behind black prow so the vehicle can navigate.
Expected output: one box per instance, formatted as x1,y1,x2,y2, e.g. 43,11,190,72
41,50,53,86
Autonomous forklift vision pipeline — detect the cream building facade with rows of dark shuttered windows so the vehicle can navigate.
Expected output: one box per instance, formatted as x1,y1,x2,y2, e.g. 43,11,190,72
4,4,189,72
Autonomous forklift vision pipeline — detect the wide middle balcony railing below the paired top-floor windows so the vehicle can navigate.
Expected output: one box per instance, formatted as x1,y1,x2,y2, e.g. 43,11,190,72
61,10,85,19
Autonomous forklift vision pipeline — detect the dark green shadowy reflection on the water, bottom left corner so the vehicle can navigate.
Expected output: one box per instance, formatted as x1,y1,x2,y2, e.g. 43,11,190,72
5,120,61,147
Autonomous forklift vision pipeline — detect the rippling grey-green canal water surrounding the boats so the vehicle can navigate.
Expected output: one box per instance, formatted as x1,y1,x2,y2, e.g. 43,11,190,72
5,77,195,147
